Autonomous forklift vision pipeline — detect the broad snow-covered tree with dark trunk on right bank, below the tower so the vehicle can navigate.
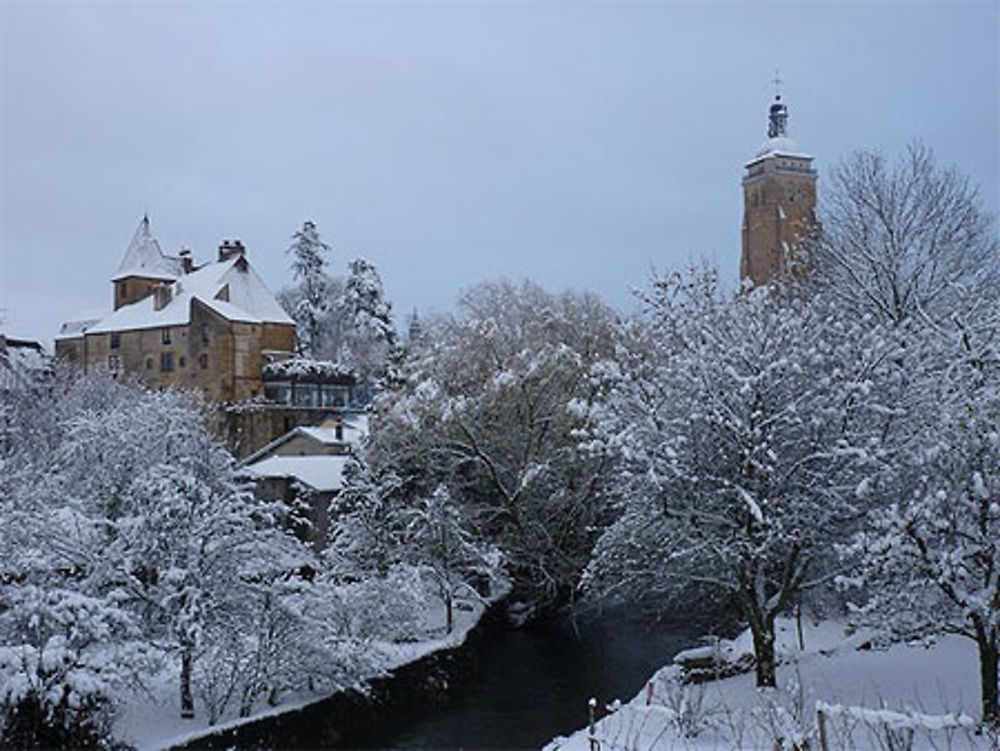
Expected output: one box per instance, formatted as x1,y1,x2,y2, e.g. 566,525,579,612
585,275,892,686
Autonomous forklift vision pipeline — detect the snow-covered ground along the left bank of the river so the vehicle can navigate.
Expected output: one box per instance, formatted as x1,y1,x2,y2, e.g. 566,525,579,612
115,588,507,751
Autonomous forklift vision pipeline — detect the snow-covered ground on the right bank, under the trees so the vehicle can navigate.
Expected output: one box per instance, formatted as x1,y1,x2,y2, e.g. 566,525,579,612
545,621,1000,751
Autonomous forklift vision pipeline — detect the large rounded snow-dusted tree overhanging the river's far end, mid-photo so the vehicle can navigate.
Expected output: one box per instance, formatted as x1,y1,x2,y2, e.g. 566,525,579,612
367,282,615,603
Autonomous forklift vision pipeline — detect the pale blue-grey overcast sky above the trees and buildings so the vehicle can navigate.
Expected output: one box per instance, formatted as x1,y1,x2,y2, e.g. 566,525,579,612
0,0,1000,346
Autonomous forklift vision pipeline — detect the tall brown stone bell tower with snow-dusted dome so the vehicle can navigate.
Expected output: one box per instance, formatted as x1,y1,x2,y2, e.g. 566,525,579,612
740,86,816,285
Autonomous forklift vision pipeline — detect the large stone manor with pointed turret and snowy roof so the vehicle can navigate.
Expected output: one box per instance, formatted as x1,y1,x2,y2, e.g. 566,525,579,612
55,217,295,403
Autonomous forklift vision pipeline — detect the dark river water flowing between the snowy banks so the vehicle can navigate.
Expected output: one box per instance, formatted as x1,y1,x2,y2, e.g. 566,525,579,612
375,618,694,749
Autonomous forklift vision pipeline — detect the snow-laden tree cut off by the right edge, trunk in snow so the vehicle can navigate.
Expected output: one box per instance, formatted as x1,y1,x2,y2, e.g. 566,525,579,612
845,308,1000,724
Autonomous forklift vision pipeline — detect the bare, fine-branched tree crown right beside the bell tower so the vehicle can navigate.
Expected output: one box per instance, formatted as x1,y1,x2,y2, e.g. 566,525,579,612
811,145,1000,322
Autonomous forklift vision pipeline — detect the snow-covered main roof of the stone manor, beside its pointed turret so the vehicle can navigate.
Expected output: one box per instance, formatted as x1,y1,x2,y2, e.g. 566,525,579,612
87,255,294,334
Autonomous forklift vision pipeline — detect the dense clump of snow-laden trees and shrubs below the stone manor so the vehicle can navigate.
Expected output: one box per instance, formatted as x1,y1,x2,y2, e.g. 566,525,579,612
0,376,419,745
